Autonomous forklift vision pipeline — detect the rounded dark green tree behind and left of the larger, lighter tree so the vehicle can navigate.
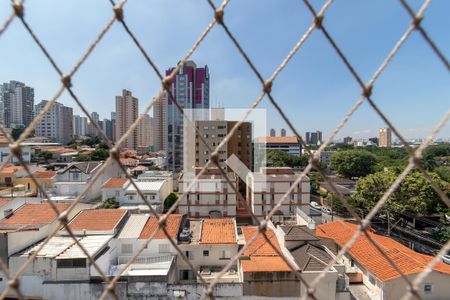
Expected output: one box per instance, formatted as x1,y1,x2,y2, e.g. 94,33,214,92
331,150,376,178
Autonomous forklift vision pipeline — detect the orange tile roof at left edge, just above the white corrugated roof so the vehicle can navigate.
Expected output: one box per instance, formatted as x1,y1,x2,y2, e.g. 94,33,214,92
0,203,70,229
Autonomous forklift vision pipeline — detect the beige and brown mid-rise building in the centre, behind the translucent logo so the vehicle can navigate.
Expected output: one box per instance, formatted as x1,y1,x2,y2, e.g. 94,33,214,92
192,120,253,169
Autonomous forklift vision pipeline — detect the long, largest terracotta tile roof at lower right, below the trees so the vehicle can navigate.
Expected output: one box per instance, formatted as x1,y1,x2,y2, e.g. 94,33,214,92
316,221,450,281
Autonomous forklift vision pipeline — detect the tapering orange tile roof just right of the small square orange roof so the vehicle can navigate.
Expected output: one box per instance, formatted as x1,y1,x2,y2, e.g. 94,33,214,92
241,226,291,273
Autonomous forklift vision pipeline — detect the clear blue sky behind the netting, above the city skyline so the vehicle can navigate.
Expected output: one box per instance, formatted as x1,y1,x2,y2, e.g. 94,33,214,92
0,0,450,139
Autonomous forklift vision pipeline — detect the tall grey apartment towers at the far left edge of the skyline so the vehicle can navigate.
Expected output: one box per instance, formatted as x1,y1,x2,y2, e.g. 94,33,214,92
0,80,34,128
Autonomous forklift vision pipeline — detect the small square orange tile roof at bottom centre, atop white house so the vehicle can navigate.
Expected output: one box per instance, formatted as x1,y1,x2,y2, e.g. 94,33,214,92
200,218,237,244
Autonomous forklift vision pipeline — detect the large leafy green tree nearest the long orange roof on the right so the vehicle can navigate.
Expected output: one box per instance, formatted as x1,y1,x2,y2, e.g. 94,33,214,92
351,170,449,215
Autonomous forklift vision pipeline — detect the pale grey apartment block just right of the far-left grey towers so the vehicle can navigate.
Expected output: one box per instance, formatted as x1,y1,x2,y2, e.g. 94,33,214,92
35,100,73,144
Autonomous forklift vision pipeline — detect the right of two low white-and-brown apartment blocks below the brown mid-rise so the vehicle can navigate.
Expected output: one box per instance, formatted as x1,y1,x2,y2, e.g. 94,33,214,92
247,167,310,222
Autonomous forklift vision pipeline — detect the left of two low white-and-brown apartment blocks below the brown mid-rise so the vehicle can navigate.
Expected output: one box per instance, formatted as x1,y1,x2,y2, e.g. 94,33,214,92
178,168,239,218
